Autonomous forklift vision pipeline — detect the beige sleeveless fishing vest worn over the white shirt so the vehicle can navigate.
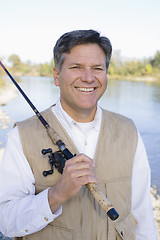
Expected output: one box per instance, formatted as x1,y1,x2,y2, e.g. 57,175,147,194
14,108,137,240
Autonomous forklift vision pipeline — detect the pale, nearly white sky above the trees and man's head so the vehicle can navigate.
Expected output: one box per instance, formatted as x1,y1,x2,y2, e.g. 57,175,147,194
0,0,160,63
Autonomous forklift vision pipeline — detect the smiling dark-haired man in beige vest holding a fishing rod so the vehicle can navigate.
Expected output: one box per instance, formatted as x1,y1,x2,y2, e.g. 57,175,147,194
0,30,157,240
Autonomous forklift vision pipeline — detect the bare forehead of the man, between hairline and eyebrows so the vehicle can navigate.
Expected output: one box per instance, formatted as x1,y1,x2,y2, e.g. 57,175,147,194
64,44,106,64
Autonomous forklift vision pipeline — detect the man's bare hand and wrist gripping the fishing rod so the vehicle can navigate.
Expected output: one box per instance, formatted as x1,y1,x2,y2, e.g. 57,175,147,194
48,154,98,213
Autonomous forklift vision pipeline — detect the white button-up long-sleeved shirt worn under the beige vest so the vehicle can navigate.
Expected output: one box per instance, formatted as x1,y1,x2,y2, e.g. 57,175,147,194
0,101,158,240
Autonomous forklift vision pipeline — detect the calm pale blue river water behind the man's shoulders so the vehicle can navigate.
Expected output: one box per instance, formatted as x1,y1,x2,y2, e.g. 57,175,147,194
0,77,160,193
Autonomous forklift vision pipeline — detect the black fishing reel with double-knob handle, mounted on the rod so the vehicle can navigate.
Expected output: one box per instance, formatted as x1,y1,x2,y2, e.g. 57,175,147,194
41,148,66,177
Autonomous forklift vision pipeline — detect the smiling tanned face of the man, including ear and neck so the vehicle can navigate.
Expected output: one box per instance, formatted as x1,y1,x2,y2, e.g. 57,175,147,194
53,44,107,121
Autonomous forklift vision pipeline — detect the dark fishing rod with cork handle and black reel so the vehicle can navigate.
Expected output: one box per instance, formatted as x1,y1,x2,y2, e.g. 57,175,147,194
0,61,119,221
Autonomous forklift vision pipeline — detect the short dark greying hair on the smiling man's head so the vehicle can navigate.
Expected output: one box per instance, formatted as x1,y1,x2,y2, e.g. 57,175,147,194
53,30,112,71
